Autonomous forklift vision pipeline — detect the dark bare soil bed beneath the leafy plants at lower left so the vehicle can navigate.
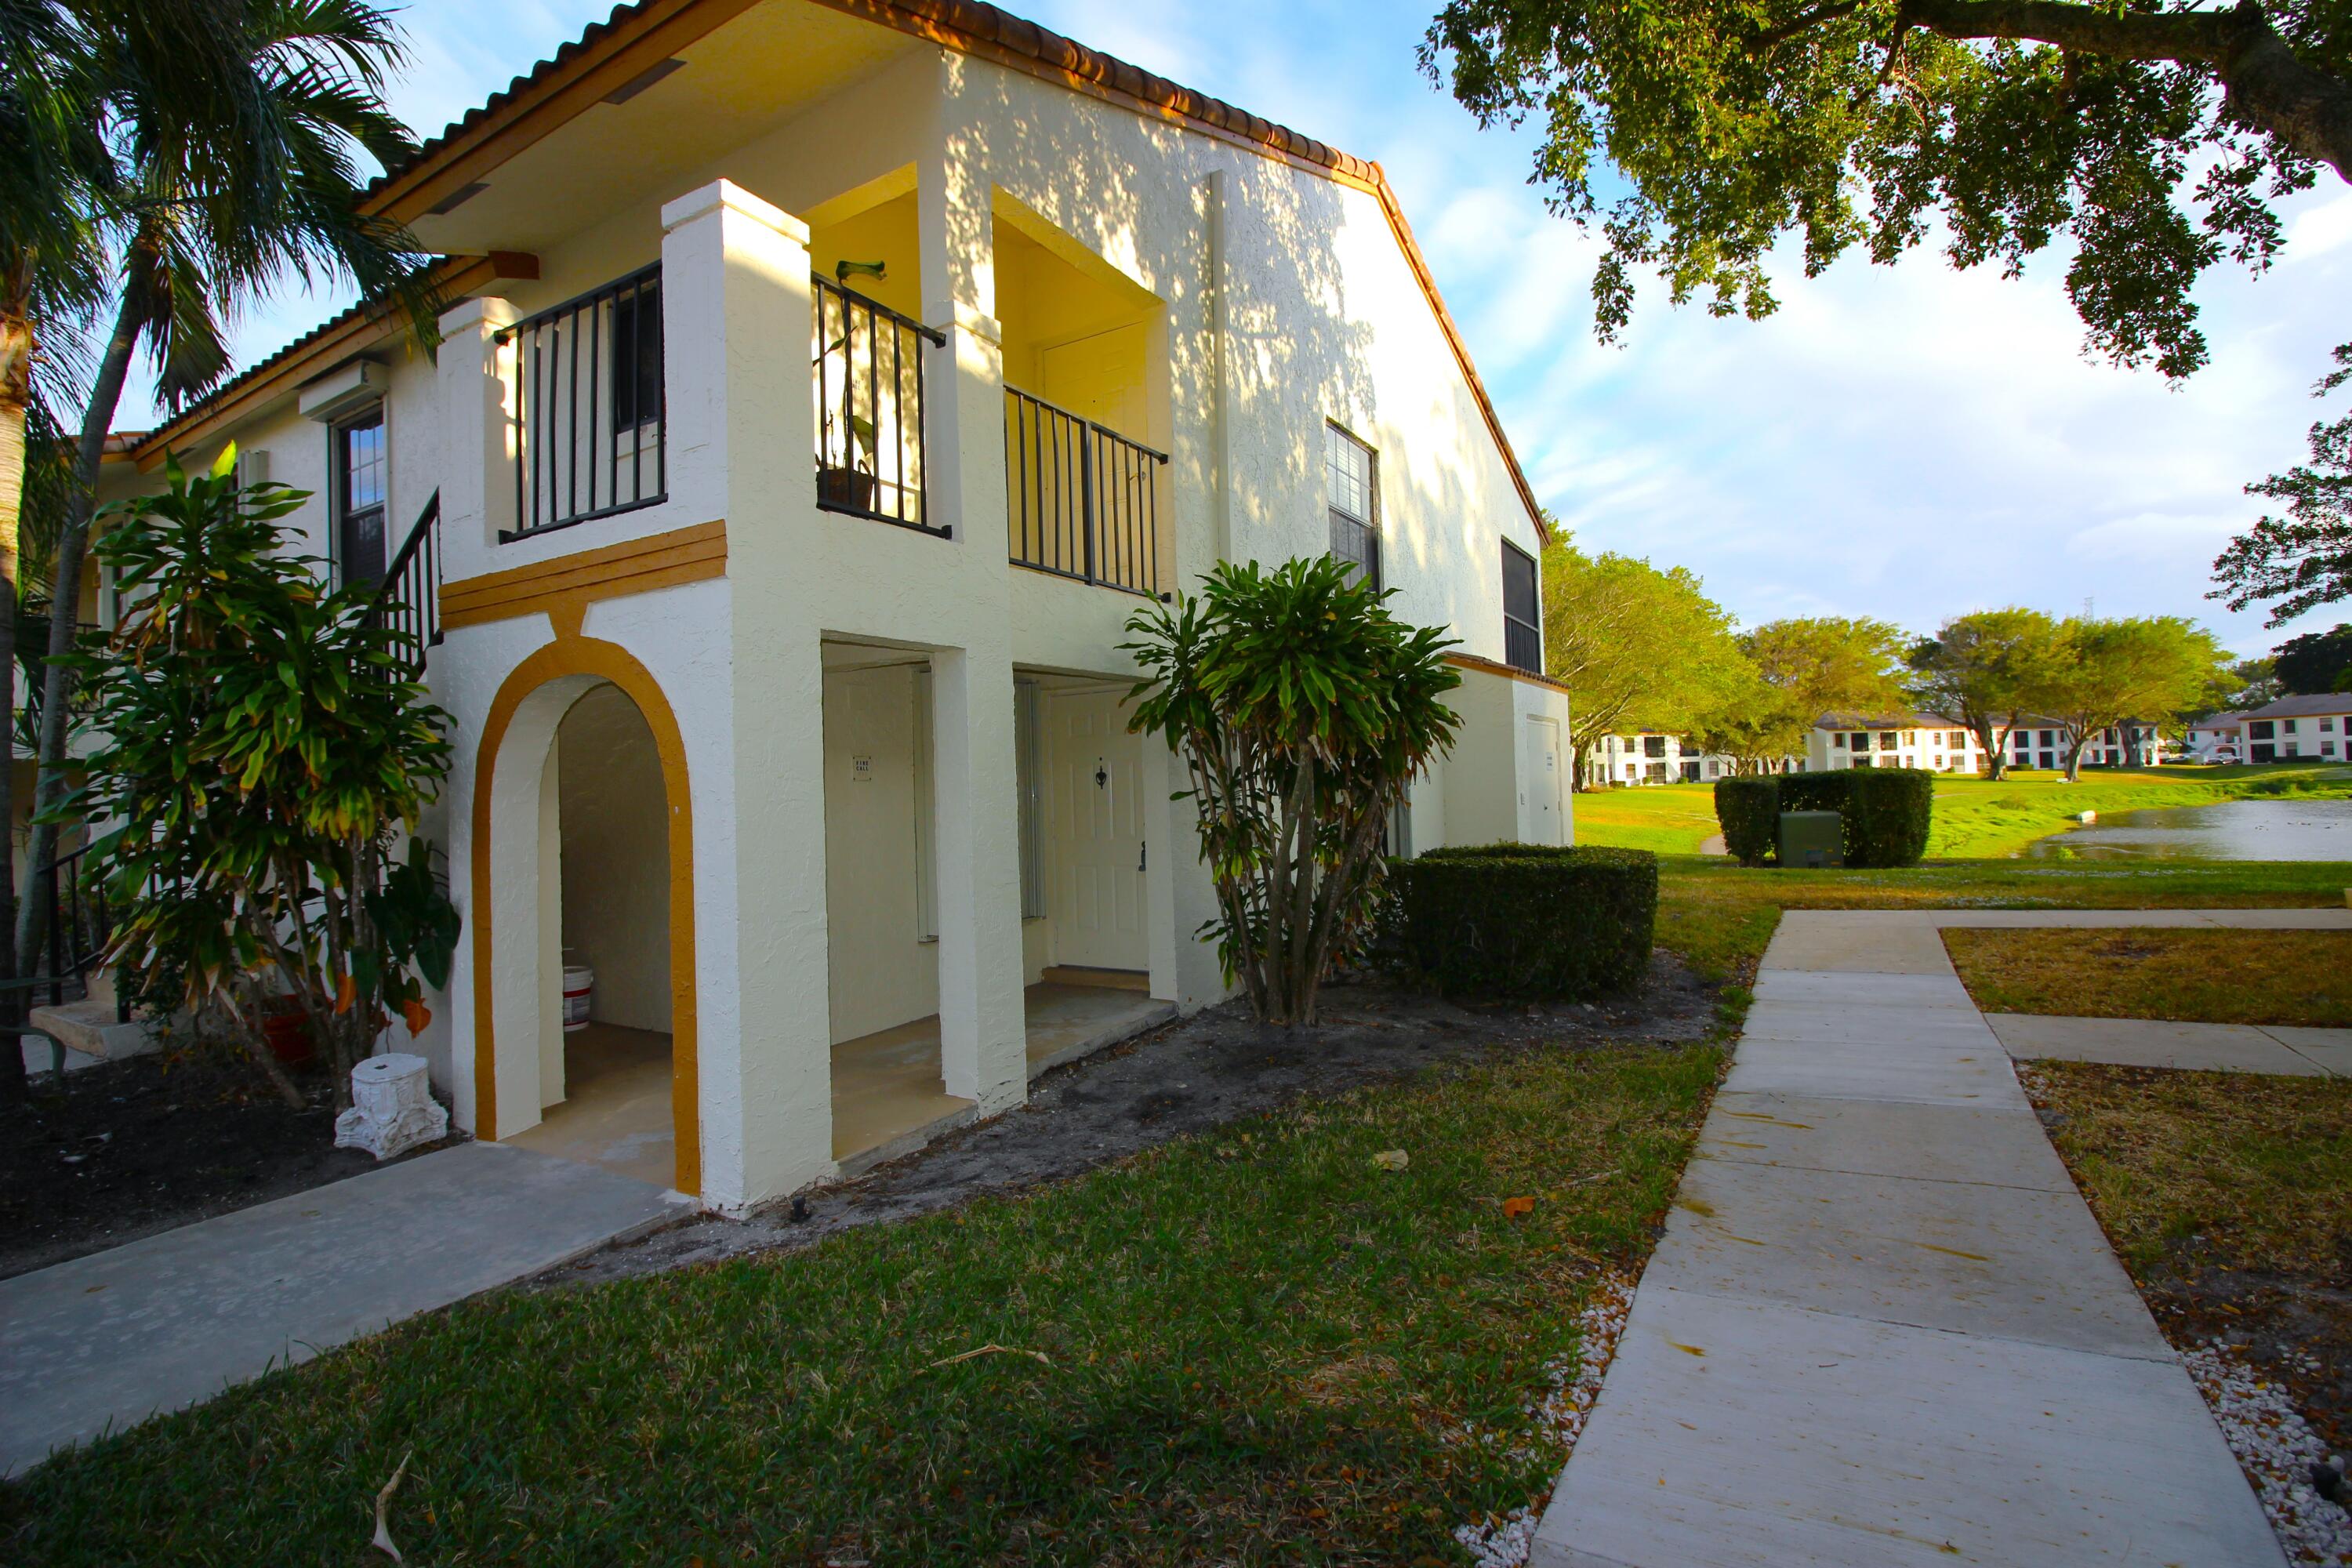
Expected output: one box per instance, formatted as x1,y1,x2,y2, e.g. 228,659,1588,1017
0,1053,445,1279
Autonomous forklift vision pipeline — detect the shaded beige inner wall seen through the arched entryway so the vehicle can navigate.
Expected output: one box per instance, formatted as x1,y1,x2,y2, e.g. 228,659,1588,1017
555,682,670,1034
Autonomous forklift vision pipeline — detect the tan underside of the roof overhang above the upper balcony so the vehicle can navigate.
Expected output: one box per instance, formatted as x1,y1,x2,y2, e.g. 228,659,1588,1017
412,0,924,256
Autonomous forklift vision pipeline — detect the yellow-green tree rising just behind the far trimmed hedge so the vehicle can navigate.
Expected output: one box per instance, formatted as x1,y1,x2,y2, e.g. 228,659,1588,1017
1703,616,1907,774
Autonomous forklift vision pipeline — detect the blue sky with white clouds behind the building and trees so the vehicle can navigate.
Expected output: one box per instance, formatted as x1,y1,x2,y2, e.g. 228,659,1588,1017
120,0,2352,654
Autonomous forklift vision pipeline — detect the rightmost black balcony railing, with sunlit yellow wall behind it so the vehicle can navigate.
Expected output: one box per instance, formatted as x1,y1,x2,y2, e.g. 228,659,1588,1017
1004,388,1169,597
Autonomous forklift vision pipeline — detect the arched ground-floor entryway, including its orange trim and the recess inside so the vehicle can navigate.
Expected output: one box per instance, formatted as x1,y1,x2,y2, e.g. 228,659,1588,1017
470,637,701,1194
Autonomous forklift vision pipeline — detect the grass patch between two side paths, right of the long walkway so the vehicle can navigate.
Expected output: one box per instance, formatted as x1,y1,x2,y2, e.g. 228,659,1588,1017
1943,928,2352,1027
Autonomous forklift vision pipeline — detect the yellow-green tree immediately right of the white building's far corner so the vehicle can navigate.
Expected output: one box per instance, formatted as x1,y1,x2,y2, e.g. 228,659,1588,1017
1543,536,1755,789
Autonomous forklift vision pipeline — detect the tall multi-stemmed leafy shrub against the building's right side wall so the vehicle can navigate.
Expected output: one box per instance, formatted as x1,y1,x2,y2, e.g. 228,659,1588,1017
1122,557,1461,1022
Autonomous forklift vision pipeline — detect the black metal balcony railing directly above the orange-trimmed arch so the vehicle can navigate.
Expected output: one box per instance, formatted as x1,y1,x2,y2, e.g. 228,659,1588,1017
499,261,670,541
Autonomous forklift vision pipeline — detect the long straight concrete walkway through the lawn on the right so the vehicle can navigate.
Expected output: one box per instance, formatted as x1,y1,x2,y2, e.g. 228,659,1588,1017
1534,912,2286,1568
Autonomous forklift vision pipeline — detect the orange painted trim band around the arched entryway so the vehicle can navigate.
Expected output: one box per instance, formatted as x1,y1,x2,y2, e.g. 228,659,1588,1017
473,635,703,1194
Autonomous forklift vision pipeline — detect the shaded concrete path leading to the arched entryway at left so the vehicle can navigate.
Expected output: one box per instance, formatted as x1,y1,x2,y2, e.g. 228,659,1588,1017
0,1142,684,1474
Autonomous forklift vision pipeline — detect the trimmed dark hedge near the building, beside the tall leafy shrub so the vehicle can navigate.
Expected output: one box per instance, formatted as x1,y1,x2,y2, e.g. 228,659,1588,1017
1390,844,1658,1001
